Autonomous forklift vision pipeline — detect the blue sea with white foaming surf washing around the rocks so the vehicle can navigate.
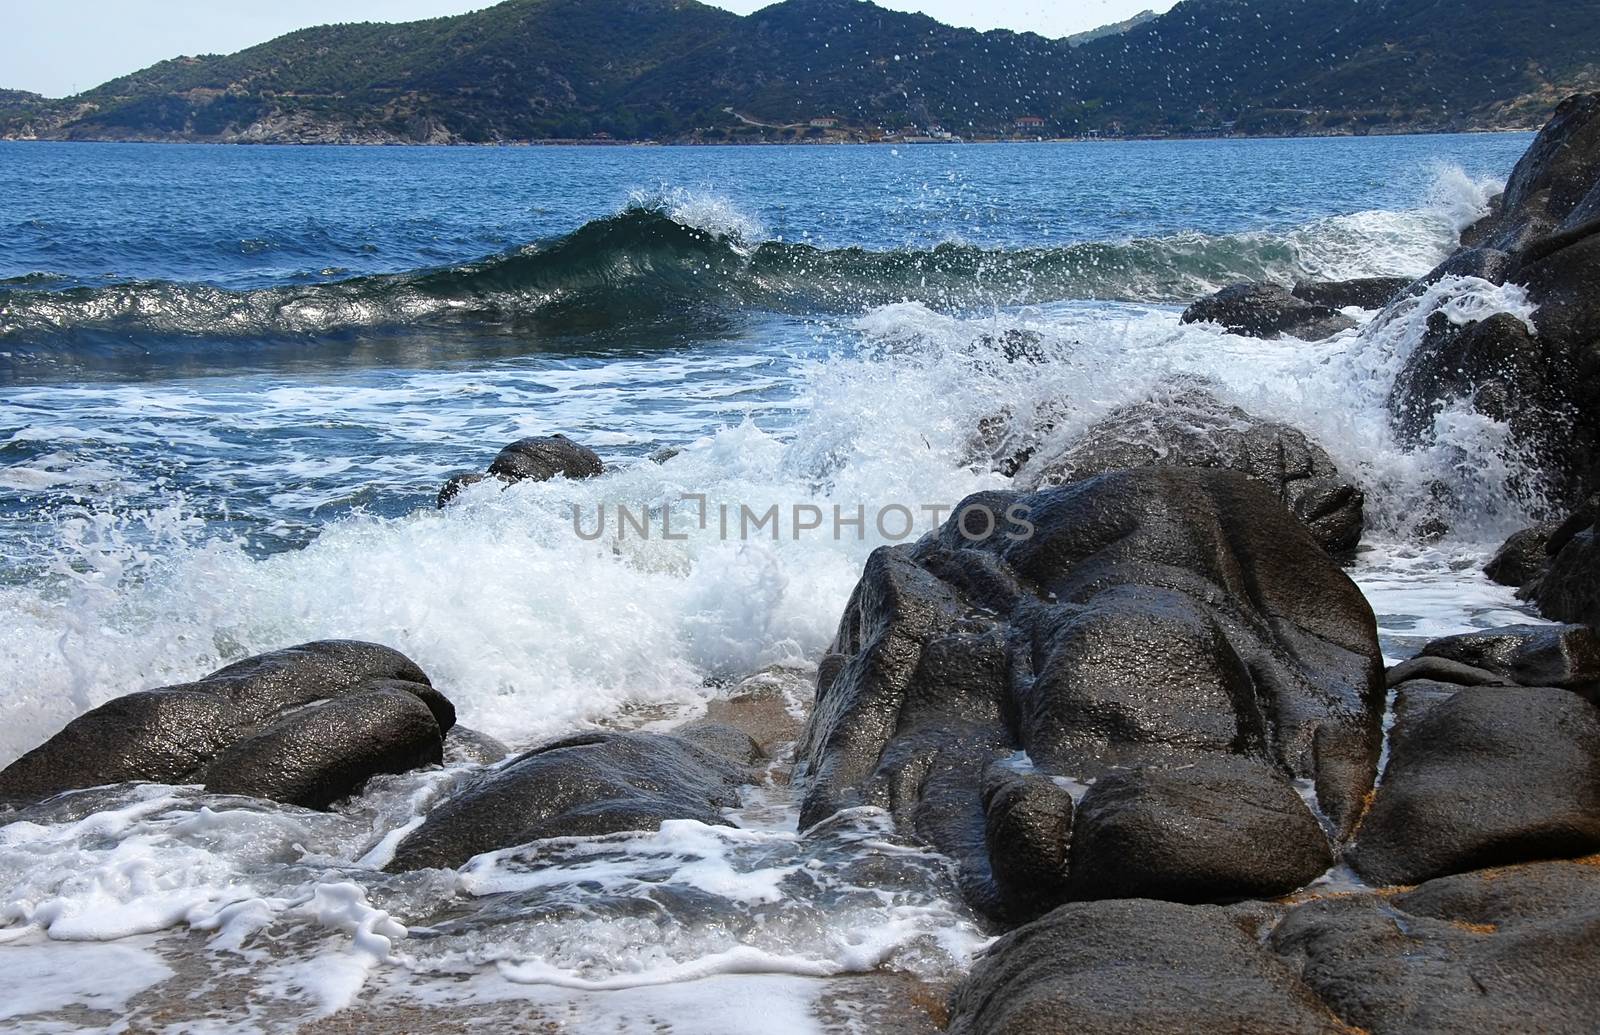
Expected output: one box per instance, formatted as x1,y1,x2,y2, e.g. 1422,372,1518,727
0,134,1541,1035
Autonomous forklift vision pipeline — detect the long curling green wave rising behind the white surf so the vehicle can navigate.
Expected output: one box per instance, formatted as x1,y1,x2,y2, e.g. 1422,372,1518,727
0,182,1485,349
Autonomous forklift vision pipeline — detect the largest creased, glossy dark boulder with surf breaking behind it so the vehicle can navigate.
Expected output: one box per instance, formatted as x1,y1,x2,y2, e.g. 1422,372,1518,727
802,467,1382,917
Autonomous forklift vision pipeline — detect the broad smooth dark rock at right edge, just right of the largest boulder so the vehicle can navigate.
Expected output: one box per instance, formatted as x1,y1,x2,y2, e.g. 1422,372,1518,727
1349,686,1600,885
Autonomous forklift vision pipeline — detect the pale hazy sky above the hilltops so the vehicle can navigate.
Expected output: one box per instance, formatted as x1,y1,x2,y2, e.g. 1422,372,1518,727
0,0,1174,98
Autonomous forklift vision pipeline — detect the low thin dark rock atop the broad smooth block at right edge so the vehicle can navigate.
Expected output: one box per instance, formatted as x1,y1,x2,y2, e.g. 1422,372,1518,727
1422,625,1600,693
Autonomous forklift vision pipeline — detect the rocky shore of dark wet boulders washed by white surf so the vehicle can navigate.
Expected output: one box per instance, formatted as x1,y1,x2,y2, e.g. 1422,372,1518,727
0,94,1600,1035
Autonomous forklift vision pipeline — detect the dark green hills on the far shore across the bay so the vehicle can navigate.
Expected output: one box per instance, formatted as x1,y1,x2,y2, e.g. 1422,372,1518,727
0,0,1600,142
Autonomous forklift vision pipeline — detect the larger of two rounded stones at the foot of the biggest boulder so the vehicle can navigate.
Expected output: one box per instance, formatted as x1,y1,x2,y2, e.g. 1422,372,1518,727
1072,757,1333,902
